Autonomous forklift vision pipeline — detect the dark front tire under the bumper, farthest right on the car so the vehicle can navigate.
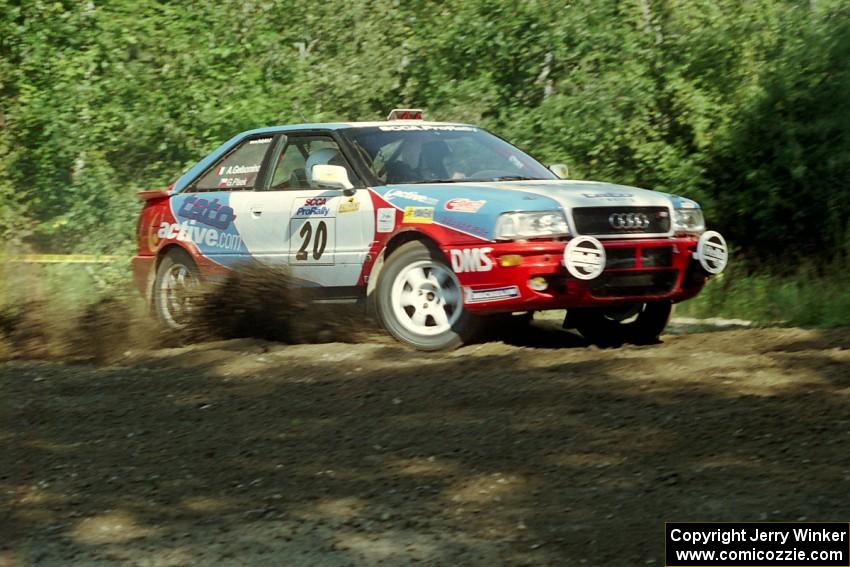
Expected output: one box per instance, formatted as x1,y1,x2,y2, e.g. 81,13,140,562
564,301,673,347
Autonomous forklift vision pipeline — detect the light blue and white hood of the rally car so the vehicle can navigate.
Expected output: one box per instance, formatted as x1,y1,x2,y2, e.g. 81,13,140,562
373,179,675,240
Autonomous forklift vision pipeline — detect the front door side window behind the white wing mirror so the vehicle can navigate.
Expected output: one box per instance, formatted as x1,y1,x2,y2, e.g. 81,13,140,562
269,136,354,191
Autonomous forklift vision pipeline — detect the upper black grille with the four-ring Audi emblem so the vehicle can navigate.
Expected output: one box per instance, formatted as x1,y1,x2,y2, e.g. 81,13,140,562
573,207,670,235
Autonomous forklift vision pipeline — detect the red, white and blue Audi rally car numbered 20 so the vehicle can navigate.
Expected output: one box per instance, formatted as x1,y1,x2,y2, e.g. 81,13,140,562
133,109,727,350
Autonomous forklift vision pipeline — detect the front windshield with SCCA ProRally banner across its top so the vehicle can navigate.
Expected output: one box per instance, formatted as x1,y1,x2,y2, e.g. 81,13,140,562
343,124,557,184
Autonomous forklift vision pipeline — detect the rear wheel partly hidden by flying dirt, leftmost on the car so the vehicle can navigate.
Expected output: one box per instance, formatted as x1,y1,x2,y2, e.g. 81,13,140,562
153,250,201,331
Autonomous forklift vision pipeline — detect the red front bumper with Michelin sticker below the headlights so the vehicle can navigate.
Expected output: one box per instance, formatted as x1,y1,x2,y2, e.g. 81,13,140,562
444,237,708,312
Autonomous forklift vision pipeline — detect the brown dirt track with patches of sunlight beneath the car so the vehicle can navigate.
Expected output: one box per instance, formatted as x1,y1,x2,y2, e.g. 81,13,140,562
0,323,850,565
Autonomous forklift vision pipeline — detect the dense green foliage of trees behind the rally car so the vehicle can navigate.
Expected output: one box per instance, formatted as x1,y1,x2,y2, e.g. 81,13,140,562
0,0,850,261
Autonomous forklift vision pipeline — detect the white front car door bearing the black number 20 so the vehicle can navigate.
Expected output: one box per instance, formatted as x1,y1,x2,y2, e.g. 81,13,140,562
229,133,374,287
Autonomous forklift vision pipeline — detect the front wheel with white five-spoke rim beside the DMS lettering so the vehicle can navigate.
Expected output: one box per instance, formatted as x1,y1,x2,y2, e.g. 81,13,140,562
375,241,478,351
